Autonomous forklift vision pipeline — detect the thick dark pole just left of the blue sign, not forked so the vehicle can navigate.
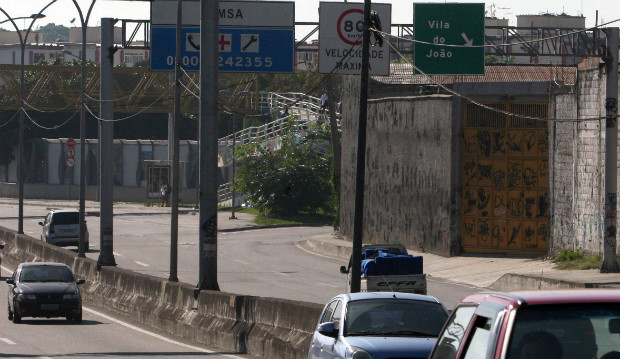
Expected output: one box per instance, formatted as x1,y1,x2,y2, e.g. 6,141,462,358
97,18,116,267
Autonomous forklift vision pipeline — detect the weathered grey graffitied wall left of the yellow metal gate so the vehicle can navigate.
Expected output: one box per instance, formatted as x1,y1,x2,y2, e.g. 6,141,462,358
340,78,454,255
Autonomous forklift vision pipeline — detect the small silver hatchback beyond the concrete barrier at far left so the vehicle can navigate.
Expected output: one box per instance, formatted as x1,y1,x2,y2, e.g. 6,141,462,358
39,210,89,250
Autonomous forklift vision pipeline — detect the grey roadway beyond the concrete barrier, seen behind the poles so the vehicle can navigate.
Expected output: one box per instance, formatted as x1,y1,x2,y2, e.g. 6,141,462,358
0,204,477,309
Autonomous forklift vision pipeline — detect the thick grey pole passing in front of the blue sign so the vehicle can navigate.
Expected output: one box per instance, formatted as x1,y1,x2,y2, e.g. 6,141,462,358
194,0,220,296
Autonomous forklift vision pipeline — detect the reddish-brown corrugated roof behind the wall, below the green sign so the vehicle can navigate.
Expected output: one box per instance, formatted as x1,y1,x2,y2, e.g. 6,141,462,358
372,64,577,85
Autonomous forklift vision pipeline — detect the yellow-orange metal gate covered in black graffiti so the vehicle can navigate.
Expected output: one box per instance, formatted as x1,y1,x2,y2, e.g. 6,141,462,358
461,102,549,254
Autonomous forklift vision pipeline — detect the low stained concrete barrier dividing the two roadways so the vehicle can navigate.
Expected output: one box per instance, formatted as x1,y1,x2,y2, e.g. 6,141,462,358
0,227,322,358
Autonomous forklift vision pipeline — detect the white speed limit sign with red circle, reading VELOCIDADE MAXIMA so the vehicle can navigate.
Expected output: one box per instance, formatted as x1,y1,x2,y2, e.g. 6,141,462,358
319,2,392,76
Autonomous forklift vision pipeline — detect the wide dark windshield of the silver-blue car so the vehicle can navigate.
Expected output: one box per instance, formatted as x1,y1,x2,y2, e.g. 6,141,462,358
345,299,448,337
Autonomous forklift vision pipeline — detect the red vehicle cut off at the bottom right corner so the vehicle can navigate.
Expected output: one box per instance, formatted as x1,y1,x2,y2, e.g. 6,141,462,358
430,289,620,359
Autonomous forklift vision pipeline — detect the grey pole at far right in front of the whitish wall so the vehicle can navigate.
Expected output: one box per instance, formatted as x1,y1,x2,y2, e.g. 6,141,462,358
600,27,620,273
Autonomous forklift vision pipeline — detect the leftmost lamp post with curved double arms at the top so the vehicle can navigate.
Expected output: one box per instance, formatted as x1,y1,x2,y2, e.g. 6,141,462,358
0,0,57,234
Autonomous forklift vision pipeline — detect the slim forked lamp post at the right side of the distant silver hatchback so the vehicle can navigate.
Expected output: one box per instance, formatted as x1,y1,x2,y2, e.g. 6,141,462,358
66,0,97,257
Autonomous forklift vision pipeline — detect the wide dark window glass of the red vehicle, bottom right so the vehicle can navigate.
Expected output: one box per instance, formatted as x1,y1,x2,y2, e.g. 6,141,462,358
506,303,620,359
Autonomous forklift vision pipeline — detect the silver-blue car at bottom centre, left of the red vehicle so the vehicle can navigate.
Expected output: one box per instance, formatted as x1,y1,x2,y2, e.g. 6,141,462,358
308,292,448,359
